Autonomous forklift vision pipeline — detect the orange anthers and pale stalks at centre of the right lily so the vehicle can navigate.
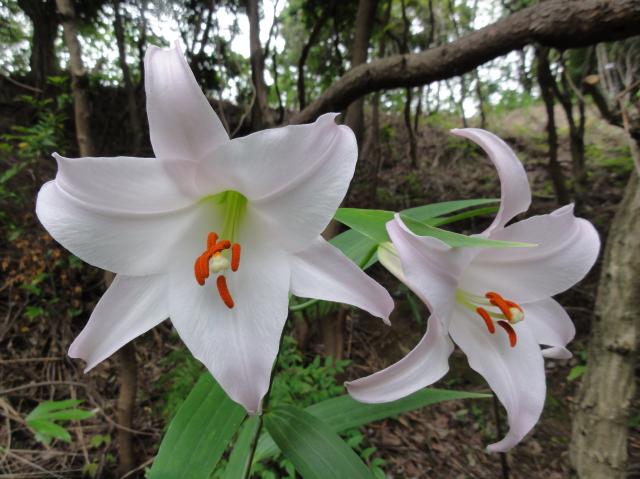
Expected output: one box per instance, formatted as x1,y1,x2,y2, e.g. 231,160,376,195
456,289,524,348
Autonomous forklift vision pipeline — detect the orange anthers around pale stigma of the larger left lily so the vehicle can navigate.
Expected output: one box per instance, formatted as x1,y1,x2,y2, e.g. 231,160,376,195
194,232,240,309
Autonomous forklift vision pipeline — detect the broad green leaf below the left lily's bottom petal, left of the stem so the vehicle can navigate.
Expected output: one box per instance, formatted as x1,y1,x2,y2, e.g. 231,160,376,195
149,373,246,479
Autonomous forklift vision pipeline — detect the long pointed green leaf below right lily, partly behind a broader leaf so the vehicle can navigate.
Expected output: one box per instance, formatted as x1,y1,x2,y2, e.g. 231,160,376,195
254,388,491,462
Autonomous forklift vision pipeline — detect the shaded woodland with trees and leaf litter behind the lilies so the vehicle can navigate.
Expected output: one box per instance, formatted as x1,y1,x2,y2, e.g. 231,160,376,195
0,0,640,478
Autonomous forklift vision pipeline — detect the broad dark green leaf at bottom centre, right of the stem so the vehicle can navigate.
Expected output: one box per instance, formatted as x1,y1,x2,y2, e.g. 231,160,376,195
264,406,371,479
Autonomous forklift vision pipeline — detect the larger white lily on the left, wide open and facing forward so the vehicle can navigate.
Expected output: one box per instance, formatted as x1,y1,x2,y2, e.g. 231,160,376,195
36,43,393,413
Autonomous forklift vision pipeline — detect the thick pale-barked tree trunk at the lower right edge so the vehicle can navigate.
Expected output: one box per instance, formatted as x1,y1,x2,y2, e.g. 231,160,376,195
570,172,640,479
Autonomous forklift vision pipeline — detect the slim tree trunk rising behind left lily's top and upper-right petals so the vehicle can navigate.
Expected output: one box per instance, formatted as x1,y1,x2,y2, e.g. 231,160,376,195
246,0,273,130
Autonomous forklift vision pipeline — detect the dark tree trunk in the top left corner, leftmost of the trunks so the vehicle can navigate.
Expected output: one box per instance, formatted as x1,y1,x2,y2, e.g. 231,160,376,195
18,0,58,90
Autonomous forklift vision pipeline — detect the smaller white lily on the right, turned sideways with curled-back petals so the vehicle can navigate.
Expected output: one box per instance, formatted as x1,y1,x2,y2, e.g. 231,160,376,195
347,128,600,451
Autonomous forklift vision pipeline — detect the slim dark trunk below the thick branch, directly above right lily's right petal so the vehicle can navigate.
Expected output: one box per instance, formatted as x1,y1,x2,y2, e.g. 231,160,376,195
536,47,570,205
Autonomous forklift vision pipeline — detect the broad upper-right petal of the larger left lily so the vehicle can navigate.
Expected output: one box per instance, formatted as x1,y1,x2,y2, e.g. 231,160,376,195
197,114,358,251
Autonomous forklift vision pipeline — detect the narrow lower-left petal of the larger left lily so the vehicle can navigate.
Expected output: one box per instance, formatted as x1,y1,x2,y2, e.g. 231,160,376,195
69,275,169,372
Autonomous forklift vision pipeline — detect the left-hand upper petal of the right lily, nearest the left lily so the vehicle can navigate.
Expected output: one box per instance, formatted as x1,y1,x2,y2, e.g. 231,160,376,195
383,214,473,325
